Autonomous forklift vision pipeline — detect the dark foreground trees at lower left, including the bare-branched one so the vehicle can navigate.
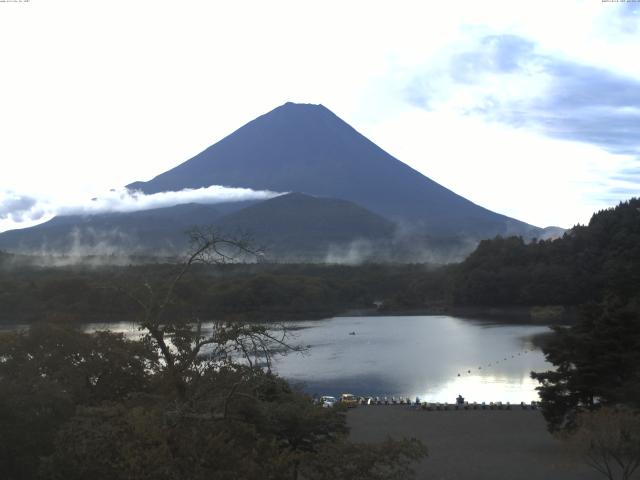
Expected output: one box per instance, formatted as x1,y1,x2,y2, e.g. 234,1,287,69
0,231,430,480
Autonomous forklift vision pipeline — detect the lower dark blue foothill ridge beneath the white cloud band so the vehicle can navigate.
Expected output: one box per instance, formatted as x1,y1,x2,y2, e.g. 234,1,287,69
0,193,395,261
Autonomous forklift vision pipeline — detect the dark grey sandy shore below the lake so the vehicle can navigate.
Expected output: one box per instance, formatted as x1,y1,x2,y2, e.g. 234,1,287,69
347,406,603,480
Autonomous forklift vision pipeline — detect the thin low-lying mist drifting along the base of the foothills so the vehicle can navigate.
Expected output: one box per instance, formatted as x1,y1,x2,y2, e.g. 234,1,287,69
0,221,478,266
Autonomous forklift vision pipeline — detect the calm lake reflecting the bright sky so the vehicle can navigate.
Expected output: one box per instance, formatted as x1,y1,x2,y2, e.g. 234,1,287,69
5,315,552,403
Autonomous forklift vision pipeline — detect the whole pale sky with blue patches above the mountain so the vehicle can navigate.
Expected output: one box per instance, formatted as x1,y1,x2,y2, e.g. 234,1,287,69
0,0,640,231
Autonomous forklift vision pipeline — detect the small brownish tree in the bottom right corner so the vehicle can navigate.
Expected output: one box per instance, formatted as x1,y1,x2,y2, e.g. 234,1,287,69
567,406,640,480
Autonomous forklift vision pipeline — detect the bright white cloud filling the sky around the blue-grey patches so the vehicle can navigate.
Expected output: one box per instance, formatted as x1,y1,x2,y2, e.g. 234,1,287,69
0,0,640,228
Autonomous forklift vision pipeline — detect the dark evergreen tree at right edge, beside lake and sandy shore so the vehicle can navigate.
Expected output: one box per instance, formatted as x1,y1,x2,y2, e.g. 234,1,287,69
532,300,640,431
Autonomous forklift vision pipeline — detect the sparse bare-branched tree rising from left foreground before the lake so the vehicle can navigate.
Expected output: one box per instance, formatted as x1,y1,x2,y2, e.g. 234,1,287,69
121,228,294,397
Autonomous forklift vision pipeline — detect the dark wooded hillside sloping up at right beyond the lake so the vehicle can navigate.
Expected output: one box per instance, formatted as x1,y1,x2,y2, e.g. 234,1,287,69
453,199,640,306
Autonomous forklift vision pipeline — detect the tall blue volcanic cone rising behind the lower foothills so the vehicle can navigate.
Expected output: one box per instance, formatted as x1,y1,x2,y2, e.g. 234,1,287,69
128,103,538,238
